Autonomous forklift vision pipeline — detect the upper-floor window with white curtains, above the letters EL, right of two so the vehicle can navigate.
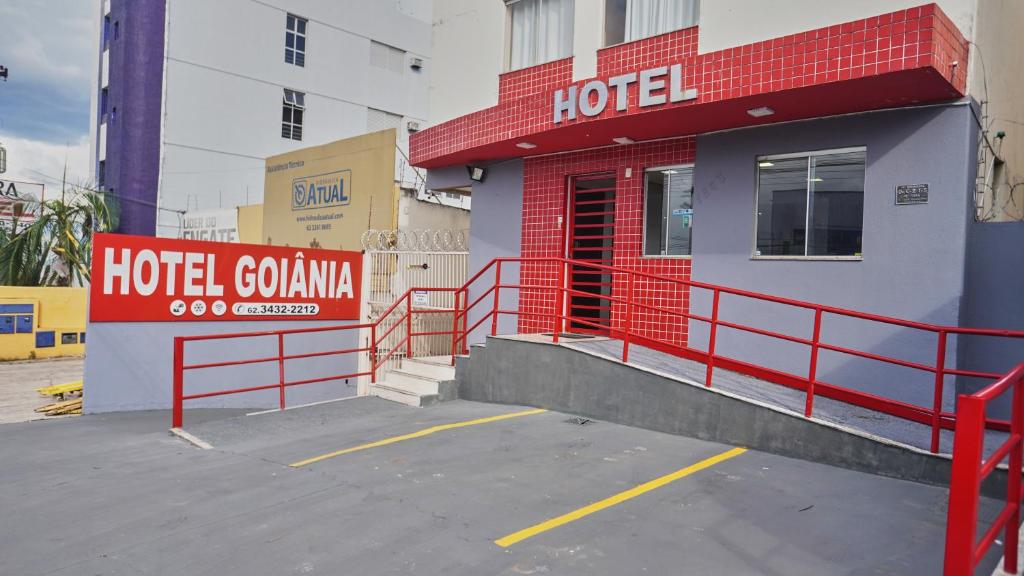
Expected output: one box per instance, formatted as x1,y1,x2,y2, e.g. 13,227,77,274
604,0,700,46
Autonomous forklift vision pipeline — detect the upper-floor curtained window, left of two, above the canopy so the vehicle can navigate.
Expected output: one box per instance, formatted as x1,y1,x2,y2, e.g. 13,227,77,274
505,0,573,70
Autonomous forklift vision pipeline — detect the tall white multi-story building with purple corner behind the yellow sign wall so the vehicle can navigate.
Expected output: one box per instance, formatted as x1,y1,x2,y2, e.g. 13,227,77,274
93,0,440,236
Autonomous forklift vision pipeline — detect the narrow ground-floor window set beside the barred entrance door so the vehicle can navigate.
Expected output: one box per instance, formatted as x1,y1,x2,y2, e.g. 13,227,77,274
643,166,693,256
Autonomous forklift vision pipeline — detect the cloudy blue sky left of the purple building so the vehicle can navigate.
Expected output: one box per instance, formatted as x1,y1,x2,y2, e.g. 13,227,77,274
0,0,98,189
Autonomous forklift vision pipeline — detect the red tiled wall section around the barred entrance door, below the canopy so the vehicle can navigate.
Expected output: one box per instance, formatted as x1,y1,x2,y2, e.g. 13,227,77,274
519,137,696,345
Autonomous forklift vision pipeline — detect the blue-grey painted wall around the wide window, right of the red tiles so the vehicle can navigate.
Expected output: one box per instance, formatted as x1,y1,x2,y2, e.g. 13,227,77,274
690,106,977,408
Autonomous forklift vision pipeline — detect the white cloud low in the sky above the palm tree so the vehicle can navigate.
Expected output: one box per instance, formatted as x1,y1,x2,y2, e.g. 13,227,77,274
0,133,89,189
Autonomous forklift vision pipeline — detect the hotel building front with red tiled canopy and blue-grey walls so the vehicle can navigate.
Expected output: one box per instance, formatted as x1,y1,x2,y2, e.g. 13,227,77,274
411,0,1024,405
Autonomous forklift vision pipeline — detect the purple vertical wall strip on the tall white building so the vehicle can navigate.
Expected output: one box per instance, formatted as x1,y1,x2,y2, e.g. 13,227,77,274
105,0,167,236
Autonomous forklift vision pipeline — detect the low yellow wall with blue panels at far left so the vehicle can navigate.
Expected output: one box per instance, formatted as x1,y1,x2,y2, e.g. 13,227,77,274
0,286,87,360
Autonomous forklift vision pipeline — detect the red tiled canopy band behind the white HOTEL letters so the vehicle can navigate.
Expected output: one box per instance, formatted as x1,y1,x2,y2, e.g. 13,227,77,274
410,4,968,165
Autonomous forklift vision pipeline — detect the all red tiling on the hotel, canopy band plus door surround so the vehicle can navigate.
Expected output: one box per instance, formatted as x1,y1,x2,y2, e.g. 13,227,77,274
410,4,968,345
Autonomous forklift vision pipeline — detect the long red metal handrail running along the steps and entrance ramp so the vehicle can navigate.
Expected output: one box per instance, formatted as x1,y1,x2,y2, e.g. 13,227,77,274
174,257,1024,452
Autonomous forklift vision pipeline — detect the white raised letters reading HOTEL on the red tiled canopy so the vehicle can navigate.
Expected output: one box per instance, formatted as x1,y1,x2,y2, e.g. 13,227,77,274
553,64,697,124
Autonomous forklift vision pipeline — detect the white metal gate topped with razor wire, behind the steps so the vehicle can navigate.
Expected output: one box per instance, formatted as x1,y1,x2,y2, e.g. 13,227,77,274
362,231,469,375
